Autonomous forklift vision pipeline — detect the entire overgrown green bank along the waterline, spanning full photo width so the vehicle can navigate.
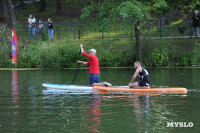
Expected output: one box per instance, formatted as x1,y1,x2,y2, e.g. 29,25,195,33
0,23,200,68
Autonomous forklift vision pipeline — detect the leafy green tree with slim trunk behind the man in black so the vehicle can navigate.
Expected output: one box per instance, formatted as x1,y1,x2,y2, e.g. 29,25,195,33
81,0,168,62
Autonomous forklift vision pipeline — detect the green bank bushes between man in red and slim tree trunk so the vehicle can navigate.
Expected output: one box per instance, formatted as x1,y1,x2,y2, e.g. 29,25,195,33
97,40,136,67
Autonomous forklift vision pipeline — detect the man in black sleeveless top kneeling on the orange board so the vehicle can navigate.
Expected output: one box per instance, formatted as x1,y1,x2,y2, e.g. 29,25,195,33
128,61,150,88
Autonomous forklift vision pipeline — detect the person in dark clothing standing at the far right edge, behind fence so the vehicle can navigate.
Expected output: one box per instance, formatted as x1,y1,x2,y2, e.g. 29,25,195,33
192,10,200,37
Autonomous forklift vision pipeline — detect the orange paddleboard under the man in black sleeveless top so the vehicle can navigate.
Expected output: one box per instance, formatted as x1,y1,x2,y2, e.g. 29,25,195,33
93,86,187,93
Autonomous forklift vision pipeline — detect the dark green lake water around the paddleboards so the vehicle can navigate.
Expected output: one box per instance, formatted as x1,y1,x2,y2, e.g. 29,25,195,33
0,68,200,133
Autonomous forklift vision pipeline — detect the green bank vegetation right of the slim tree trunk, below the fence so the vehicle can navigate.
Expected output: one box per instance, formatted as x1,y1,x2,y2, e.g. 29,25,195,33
142,39,200,67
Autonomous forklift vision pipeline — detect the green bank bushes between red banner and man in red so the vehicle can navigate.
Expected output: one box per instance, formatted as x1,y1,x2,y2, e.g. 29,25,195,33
18,42,79,68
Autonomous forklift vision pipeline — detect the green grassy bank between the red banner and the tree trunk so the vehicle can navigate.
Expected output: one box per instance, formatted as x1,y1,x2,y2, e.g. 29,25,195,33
15,40,135,68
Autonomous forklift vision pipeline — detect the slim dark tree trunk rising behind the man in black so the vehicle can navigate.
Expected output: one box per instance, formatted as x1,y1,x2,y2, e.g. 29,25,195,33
135,21,142,64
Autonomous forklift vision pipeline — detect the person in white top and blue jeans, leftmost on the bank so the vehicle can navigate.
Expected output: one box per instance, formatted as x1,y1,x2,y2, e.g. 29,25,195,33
28,14,36,39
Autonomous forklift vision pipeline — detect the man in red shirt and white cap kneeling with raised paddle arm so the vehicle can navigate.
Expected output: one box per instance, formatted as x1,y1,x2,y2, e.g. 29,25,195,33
78,44,111,86
